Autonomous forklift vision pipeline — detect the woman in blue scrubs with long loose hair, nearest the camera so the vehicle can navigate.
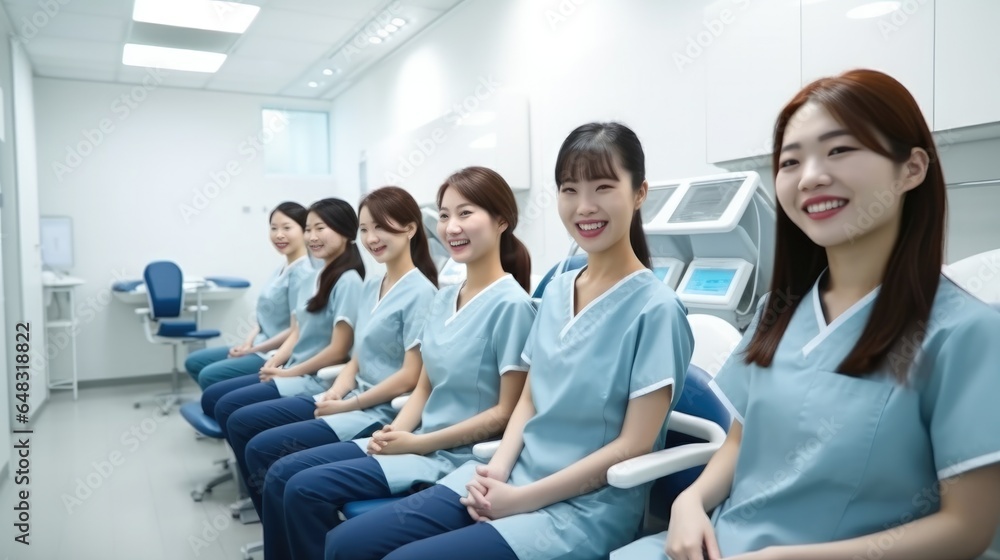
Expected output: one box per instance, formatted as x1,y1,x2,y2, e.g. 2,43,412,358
612,70,1000,560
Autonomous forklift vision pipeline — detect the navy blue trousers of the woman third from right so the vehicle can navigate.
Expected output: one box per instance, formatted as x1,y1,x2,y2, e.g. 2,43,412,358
261,442,391,560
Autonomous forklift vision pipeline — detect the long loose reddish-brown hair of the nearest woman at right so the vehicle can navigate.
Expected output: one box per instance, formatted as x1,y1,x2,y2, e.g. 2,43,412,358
745,70,946,381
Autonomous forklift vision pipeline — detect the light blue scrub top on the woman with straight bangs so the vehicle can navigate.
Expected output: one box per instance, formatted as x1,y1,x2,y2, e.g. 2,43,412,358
440,269,694,560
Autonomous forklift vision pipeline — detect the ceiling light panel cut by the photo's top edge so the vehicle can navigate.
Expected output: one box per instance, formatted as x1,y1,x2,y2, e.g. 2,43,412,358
132,0,260,33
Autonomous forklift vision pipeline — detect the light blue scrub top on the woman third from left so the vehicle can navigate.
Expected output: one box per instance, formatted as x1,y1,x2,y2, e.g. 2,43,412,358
322,268,437,441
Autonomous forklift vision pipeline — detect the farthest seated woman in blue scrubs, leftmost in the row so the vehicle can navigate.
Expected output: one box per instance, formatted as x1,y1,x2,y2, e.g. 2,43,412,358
184,202,313,390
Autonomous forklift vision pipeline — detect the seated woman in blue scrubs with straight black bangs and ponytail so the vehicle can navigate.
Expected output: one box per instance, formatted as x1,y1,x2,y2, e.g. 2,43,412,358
326,123,693,560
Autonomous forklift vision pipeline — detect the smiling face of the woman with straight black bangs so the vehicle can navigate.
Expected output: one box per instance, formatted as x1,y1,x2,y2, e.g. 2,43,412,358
559,158,648,254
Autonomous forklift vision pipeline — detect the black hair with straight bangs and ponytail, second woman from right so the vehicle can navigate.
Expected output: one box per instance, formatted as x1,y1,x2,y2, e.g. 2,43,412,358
556,122,653,268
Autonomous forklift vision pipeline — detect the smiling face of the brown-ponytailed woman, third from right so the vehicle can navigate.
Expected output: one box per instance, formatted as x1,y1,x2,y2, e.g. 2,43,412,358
437,188,507,264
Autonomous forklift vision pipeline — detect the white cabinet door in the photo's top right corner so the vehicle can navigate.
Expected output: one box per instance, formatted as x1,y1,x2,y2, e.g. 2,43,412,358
934,0,1000,130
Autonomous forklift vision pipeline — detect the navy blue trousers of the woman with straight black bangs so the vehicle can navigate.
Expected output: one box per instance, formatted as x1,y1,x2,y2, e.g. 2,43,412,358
325,484,517,560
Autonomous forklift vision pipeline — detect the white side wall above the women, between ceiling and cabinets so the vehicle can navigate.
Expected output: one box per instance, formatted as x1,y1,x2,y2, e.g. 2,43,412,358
333,0,732,274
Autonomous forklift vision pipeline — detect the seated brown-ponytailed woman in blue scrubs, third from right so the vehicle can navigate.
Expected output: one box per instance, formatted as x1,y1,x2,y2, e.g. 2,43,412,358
262,167,535,559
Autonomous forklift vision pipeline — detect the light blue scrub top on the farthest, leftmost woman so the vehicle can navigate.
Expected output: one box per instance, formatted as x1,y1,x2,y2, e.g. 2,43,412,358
253,256,315,352
